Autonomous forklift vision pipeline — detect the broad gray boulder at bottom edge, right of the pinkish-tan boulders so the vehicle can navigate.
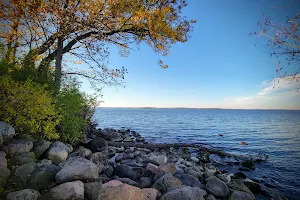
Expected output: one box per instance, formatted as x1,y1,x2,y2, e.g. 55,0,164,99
161,186,207,200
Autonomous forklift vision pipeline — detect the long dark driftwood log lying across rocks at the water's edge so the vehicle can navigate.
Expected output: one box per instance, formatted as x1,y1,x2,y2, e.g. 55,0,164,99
106,141,247,159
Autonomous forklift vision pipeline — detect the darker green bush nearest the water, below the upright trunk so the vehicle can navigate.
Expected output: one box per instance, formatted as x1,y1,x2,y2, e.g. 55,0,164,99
56,84,95,143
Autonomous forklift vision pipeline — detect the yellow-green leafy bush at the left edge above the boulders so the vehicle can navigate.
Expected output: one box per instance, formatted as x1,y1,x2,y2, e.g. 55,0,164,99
0,75,60,139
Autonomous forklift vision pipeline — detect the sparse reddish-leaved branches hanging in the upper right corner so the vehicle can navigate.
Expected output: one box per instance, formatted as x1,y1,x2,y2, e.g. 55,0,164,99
254,0,300,84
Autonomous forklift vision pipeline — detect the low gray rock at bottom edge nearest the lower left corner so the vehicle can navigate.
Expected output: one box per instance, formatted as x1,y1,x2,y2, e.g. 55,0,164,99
6,189,41,200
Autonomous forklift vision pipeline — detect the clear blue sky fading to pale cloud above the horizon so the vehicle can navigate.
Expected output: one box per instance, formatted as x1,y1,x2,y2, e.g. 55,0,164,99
79,0,300,109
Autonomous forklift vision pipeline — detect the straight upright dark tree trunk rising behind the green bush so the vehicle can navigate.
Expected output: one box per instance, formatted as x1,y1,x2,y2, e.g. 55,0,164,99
54,36,63,95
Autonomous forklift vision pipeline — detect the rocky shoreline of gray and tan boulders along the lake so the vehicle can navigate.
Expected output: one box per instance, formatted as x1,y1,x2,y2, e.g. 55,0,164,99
0,122,286,200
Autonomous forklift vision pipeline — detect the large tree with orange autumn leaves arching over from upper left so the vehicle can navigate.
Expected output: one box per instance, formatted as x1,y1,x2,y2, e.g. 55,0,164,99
0,0,195,91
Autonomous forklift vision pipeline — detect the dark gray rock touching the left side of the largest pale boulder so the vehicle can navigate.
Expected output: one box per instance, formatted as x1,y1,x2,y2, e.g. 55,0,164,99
28,164,60,190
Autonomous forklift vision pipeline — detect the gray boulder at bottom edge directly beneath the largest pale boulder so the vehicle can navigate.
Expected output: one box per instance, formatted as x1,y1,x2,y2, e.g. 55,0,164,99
39,181,84,200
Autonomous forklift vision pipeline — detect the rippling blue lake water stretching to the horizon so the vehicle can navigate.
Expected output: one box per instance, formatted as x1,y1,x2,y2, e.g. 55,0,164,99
94,108,300,199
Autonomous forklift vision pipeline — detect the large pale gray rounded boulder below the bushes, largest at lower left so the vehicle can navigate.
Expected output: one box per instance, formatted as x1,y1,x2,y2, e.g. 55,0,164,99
55,157,99,183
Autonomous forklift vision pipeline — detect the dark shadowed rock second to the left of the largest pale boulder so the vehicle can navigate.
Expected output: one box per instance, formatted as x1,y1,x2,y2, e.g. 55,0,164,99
8,163,36,188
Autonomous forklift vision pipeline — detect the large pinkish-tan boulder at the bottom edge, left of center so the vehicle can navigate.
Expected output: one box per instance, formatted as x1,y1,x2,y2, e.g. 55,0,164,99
100,184,143,200
